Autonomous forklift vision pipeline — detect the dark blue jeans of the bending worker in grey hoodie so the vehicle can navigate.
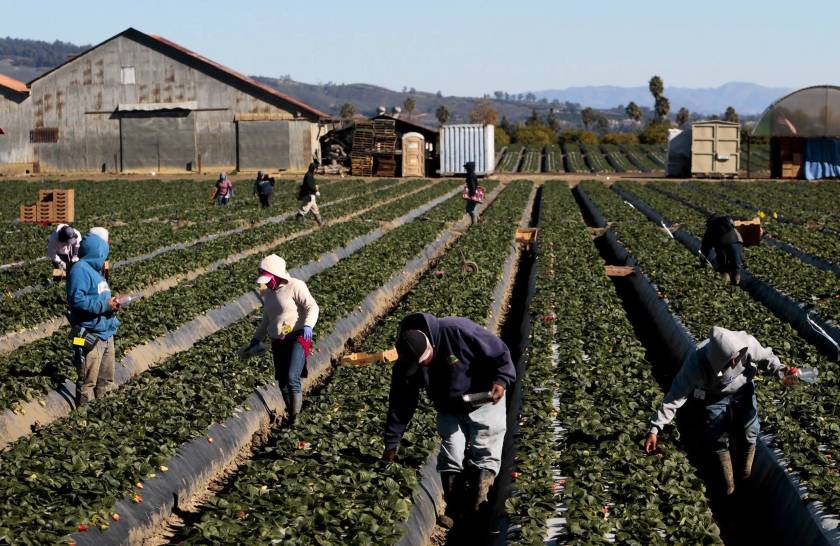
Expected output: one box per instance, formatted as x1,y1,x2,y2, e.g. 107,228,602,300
704,382,760,453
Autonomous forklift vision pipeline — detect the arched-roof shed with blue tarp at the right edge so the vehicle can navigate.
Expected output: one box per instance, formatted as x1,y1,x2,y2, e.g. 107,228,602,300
751,85,840,180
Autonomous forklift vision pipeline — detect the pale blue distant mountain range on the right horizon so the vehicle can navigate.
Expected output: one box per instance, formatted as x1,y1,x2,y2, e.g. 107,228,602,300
532,82,793,115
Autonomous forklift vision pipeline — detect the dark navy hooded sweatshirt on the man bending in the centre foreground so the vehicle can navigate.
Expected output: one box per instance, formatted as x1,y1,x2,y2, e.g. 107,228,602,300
385,313,516,449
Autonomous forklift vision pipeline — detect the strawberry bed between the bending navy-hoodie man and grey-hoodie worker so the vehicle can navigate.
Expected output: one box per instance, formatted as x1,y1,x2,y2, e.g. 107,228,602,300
507,182,720,545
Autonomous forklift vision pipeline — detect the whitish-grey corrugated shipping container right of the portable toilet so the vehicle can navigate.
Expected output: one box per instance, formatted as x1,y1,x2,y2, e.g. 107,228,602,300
440,123,496,176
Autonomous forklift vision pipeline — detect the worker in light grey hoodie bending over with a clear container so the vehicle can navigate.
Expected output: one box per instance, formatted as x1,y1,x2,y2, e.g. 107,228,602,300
645,326,794,495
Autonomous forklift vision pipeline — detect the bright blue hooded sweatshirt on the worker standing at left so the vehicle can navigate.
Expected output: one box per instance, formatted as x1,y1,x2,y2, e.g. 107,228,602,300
67,233,120,340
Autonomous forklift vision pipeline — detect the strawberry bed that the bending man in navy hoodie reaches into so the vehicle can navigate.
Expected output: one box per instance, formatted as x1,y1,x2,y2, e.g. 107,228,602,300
169,182,532,544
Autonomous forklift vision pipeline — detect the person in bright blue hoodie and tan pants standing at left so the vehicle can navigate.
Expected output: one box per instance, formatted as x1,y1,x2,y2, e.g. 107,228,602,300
67,227,120,406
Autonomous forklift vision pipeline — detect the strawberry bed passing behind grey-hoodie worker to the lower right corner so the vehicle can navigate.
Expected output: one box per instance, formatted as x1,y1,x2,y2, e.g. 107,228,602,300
583,183,840,529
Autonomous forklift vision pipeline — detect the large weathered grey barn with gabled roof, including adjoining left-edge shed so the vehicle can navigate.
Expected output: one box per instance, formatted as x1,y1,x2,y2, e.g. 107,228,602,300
0,28,328,172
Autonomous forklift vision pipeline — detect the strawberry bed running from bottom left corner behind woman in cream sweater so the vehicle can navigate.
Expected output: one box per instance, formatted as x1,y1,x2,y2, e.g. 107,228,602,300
0,184,492,543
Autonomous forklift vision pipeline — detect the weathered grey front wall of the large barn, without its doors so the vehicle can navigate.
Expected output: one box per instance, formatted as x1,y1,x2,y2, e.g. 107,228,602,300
29,36,312,171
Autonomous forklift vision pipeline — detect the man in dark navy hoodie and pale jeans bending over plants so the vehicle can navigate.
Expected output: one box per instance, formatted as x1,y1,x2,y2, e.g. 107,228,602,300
382,313,516,527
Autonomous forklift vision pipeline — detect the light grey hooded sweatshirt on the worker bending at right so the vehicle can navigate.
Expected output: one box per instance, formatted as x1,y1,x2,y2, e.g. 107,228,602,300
650,326,786,433
